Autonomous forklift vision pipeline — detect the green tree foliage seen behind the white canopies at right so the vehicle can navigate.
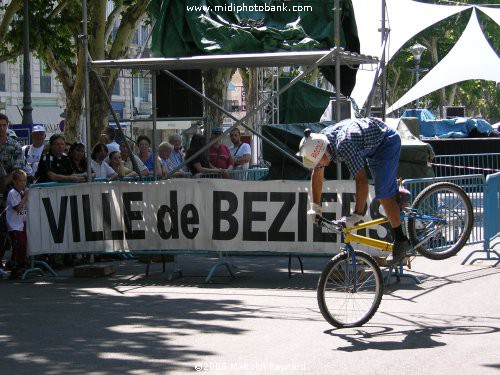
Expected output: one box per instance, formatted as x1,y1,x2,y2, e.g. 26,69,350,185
387,0,500,123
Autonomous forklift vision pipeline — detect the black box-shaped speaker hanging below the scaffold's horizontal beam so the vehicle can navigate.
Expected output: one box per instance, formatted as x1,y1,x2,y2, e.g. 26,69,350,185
156,69,203,117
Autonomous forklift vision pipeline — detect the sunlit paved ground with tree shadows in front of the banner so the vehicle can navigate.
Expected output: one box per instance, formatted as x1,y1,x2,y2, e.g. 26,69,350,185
0,247,500,375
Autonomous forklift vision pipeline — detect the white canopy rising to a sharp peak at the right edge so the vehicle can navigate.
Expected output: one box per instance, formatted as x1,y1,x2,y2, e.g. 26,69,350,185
387,9,500,113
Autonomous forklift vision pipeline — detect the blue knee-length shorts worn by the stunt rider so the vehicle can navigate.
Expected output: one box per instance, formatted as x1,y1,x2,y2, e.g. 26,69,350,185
366,128,401,199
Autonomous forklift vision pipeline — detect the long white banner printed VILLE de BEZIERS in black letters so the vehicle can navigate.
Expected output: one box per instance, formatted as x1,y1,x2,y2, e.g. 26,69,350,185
28,179,387,255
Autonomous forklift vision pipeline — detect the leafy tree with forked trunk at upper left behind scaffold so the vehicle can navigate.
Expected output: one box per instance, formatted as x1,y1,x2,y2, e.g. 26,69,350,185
0,0,149,141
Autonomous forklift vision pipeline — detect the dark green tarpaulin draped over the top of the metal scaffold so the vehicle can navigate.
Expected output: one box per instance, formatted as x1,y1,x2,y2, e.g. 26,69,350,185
150,0,360,96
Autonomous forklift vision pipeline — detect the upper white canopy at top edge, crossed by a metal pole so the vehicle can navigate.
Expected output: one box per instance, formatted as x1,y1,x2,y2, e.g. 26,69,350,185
351,0,471,106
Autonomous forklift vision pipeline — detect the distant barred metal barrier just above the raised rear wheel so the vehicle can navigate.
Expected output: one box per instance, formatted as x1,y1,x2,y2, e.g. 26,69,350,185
431,153,500,177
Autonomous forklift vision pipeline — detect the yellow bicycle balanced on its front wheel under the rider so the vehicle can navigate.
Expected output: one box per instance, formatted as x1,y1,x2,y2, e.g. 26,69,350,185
317,182,473,328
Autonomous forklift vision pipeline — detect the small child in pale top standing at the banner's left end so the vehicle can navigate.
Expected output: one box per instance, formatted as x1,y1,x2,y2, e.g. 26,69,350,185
6,169,28,279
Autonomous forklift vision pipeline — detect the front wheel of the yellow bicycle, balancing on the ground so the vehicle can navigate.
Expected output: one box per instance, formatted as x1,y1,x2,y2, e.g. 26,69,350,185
317,251,384,328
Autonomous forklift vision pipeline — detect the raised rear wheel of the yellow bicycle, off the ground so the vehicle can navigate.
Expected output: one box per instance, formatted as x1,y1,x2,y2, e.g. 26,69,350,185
407,182,474,260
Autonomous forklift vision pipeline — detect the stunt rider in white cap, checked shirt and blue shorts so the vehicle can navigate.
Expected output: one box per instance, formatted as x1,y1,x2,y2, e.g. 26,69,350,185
298,118,410,265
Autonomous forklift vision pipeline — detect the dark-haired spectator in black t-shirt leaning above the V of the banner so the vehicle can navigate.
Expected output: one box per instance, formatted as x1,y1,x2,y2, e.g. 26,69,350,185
36,134,86,182
